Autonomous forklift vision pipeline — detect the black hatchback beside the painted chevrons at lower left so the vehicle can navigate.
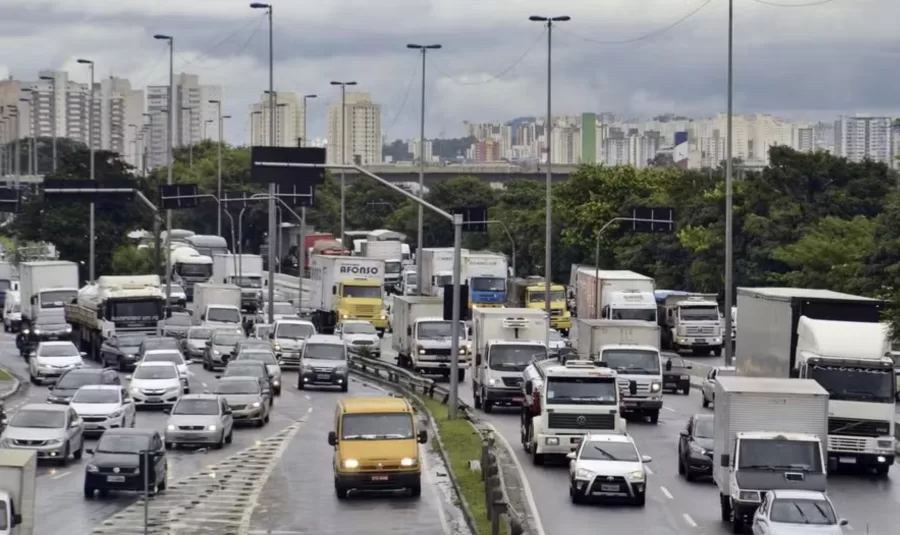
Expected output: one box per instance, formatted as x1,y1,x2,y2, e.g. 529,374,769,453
84,428,168,498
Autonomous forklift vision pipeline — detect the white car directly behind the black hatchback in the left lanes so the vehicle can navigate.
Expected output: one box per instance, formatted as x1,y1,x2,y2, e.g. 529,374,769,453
69,385,137,435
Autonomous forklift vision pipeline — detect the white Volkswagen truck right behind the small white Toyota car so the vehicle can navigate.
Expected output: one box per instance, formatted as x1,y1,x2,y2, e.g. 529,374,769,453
520,359,625,465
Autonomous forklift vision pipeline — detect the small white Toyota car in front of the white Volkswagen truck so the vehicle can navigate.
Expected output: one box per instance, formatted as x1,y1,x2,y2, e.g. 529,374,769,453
567,435,652,507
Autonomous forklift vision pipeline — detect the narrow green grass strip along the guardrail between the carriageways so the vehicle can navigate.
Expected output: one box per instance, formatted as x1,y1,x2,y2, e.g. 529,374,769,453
423,398,500,535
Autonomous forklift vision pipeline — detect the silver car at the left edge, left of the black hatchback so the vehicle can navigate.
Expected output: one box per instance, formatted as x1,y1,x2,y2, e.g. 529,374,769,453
0,403,84,466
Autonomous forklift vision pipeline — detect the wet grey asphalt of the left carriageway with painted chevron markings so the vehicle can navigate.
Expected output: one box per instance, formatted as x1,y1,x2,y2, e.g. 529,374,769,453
0,334,468,535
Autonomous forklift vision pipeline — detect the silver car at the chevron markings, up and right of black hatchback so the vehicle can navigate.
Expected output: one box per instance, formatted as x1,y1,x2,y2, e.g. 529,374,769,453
165,394,234,449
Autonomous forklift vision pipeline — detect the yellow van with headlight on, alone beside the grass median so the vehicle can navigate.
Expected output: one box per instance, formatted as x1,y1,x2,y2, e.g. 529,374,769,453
328,397,428,499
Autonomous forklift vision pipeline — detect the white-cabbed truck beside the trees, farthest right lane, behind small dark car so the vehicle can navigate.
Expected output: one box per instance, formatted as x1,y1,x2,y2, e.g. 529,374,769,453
656,290,725,357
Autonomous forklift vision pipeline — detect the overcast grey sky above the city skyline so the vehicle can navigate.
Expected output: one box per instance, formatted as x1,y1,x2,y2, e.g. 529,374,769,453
0,0,900,143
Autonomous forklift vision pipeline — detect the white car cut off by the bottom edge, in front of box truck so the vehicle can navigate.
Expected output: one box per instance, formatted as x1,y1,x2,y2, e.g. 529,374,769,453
752,490,848,535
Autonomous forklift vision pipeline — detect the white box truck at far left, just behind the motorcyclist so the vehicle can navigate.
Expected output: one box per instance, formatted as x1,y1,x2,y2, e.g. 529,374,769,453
19,260,78,325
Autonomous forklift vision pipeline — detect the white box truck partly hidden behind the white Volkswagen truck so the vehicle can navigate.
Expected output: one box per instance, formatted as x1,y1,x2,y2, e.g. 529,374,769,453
575,318,663,424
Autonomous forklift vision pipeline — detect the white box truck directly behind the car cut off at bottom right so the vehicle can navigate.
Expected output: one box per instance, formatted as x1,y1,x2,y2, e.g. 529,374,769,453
713,376,828,533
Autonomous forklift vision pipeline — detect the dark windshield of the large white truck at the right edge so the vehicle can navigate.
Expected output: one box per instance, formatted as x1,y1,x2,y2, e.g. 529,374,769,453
809,365,895,404
